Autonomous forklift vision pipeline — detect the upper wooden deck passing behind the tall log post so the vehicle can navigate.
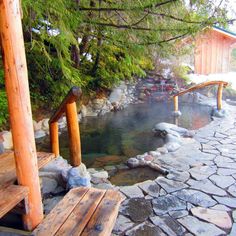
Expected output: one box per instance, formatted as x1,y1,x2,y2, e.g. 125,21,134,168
0,151,55,185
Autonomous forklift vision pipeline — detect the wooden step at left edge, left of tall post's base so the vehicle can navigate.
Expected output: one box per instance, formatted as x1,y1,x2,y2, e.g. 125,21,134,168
0,185,29,218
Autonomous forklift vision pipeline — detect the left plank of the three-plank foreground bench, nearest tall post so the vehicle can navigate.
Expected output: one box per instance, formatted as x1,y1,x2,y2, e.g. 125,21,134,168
33,187,89,236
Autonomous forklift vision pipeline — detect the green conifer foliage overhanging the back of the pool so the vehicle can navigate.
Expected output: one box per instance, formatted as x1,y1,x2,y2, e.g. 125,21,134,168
0,0,232,120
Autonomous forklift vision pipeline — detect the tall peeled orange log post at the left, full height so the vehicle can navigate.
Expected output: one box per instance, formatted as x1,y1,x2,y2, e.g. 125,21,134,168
0,0,43,230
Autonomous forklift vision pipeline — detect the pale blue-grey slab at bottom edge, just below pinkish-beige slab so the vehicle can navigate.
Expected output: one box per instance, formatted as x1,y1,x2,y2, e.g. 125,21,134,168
178,216,226,236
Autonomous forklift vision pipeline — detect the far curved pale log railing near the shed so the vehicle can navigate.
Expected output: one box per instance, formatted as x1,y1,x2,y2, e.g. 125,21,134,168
173,81,228,112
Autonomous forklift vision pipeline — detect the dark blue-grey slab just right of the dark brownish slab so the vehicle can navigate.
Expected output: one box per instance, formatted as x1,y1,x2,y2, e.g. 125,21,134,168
152,195,186,215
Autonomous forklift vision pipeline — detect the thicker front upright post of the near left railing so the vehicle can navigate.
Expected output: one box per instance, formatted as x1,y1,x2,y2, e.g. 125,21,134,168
66,102,81,166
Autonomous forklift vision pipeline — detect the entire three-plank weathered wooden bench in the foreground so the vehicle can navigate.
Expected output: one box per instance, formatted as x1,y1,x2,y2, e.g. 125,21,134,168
33,187,124,236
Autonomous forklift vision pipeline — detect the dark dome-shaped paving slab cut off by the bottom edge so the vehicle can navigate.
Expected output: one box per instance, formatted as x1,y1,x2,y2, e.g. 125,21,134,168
125,222,166,236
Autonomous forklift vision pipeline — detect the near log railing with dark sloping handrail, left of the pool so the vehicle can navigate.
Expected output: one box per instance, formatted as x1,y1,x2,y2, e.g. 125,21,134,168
49,87,82,166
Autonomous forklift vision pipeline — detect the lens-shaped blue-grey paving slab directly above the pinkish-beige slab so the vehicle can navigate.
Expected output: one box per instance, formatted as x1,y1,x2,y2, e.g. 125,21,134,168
172,189,217,207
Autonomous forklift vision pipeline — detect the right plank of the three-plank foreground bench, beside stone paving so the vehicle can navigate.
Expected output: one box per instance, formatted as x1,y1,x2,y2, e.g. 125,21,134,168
81,190,123,236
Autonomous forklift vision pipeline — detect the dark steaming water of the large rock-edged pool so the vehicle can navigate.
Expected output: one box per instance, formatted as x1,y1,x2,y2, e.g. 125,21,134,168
38,102,211,167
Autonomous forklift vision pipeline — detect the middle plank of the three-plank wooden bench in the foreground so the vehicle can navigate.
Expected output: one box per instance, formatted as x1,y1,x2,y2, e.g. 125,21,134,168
55,188,106,236
